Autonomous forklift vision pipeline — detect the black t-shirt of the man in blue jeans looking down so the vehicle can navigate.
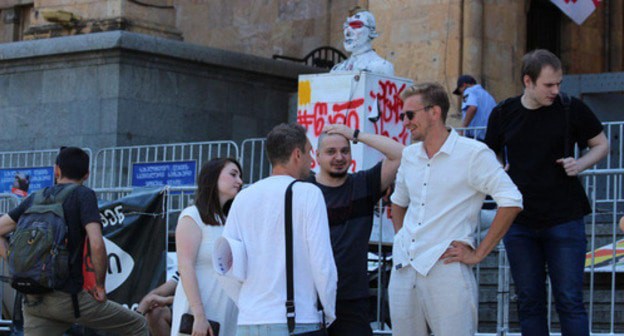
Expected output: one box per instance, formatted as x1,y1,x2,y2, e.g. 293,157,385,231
485,97,602,229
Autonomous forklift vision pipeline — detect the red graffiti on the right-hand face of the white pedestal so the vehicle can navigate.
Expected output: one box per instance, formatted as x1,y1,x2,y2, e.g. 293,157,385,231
368,80,409,145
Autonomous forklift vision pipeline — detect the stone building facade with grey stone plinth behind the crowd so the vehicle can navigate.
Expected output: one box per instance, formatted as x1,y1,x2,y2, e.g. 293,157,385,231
0,0,624,331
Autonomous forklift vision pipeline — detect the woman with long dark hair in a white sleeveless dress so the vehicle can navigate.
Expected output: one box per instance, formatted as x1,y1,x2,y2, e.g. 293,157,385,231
171,158,243,336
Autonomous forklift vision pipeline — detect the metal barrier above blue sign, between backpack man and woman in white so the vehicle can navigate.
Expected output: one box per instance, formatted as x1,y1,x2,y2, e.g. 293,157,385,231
91,141,239,192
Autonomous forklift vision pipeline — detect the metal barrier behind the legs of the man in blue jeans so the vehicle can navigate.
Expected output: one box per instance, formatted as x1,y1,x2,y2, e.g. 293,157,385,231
468,169,624,335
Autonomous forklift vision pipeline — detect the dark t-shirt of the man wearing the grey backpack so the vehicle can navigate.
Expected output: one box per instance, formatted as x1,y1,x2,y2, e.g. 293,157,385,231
9,184,100,294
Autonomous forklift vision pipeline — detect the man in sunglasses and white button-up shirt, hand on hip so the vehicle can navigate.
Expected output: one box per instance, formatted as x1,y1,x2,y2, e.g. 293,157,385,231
388,83,522,336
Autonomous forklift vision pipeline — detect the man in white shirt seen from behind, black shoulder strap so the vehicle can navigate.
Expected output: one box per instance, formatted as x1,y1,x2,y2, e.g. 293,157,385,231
223,124,338,336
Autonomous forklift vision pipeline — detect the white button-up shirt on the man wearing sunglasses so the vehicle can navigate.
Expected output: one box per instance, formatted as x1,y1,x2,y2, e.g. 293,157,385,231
391,130,522,276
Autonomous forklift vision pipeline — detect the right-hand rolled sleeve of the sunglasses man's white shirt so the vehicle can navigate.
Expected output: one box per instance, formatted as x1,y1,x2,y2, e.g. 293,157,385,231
468,147,522,208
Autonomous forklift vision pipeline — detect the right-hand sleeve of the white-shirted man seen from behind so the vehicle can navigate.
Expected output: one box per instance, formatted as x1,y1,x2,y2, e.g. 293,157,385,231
305,187,338,323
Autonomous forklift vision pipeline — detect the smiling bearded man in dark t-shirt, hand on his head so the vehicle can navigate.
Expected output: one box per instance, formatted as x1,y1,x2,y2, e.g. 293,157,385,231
309,124,404,336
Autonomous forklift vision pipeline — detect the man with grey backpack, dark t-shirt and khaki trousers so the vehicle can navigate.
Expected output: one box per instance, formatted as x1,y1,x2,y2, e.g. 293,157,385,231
0,147,148,336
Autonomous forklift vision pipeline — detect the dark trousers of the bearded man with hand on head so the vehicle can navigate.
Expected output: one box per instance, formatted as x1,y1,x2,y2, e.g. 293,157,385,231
327,298,373,336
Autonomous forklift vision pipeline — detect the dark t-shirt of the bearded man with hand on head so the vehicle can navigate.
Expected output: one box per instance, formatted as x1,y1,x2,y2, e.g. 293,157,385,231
308,162,382,300
